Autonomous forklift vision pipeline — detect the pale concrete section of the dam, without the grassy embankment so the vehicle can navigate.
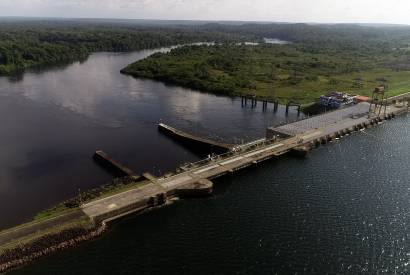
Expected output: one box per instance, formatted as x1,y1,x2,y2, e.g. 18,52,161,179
81,99,409,225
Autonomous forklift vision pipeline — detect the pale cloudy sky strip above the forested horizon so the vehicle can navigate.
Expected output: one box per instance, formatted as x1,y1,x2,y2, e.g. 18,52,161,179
0,0,410,24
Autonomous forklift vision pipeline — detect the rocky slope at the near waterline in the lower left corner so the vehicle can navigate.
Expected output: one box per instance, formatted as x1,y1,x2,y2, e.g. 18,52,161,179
0,223,106,273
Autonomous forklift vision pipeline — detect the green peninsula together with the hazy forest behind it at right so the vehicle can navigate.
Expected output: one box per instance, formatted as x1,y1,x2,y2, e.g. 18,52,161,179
123,24,410,103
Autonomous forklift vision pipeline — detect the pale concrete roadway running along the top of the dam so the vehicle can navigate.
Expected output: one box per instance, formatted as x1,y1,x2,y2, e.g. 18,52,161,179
82,102,406,223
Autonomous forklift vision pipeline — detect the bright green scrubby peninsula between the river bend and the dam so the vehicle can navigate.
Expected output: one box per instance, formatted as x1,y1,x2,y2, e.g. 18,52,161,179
123,44,410,103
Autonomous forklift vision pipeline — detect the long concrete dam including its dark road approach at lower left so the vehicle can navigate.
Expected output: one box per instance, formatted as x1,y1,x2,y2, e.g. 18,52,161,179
0,97,409,268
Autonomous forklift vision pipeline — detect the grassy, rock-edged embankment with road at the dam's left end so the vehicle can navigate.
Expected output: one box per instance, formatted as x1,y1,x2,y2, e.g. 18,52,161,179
0,177,148,274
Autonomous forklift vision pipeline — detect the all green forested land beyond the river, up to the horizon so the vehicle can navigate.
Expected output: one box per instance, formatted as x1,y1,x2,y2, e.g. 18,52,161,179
4,19,410,103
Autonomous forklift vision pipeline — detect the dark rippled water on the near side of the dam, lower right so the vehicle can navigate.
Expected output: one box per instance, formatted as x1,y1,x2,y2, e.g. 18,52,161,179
12,116,410,274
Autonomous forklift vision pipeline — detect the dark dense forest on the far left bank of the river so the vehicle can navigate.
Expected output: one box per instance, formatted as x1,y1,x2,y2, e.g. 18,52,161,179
0,21,252,75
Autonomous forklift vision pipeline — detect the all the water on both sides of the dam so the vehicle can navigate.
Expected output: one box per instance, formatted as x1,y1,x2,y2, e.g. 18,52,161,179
0,49,410,274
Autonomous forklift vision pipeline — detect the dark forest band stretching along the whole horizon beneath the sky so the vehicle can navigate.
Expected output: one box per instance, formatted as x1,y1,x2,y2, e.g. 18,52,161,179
4,20,410,77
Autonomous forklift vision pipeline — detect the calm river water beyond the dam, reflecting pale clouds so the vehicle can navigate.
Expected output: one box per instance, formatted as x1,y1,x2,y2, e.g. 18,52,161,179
0,49,296,228
